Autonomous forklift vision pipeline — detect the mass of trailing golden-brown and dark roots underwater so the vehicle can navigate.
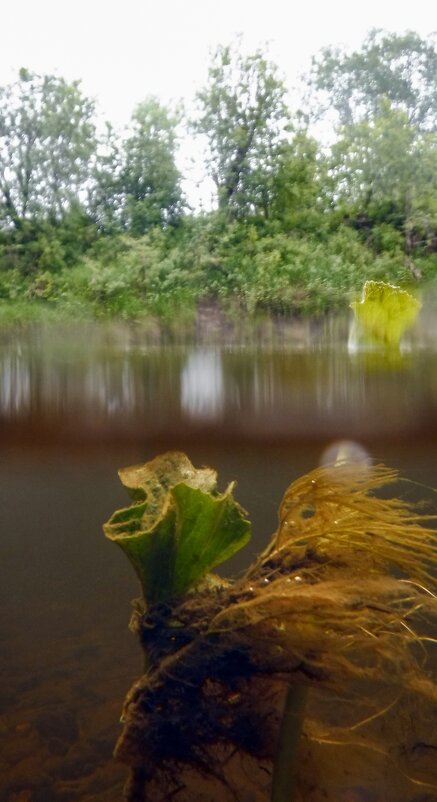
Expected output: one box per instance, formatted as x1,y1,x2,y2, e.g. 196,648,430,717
116,466,437,802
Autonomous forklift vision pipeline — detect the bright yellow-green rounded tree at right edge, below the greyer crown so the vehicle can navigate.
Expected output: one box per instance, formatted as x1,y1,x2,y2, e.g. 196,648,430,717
331,100,437,252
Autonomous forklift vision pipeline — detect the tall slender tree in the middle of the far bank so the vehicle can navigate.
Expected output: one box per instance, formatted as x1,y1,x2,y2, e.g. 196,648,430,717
193,40,289,217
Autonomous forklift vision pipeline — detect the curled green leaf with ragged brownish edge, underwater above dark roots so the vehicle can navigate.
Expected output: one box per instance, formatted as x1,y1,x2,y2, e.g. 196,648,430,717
103,451,251,604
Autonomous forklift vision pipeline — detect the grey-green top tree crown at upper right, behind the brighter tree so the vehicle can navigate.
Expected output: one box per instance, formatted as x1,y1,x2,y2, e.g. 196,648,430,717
310,30,437,130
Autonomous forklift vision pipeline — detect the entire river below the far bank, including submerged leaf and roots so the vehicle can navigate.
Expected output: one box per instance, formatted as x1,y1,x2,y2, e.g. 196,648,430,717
0,310,437,802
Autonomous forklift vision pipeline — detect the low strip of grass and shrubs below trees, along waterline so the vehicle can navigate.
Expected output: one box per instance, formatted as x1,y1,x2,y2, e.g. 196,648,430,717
0,218,437,324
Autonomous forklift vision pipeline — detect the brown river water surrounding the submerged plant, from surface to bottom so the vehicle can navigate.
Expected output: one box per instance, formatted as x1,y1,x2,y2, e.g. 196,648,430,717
0,320,437,802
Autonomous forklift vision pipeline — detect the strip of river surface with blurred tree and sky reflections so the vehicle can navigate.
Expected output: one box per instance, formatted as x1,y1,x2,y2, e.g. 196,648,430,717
0,320,437,439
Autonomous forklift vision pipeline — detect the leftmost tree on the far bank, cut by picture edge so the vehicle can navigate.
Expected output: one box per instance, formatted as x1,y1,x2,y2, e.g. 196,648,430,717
0,69,95,230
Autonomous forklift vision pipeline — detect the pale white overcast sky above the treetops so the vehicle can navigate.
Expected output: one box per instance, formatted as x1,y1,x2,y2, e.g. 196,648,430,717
0,0,437,203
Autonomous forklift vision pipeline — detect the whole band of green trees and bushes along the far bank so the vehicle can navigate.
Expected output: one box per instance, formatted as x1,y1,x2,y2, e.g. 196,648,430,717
0,31,437,321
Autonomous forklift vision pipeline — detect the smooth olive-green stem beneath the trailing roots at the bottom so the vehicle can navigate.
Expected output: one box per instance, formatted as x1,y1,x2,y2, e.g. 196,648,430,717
271,685,308,802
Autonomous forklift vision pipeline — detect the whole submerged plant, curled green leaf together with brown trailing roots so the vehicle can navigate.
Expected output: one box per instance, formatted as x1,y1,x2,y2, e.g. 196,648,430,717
105,452,437,802
